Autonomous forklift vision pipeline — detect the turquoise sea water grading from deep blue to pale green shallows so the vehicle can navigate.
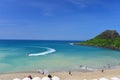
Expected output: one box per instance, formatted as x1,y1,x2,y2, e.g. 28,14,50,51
0,40,120,73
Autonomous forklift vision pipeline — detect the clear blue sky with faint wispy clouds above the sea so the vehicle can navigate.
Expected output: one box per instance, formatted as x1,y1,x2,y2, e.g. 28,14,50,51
0,0,120,40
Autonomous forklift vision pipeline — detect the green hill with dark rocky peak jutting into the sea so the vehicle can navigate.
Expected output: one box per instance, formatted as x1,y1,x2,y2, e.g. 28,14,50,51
75,30,120,50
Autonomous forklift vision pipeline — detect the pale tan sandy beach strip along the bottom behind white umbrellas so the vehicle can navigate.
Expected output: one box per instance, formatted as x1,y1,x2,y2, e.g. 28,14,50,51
0,68,120,80
